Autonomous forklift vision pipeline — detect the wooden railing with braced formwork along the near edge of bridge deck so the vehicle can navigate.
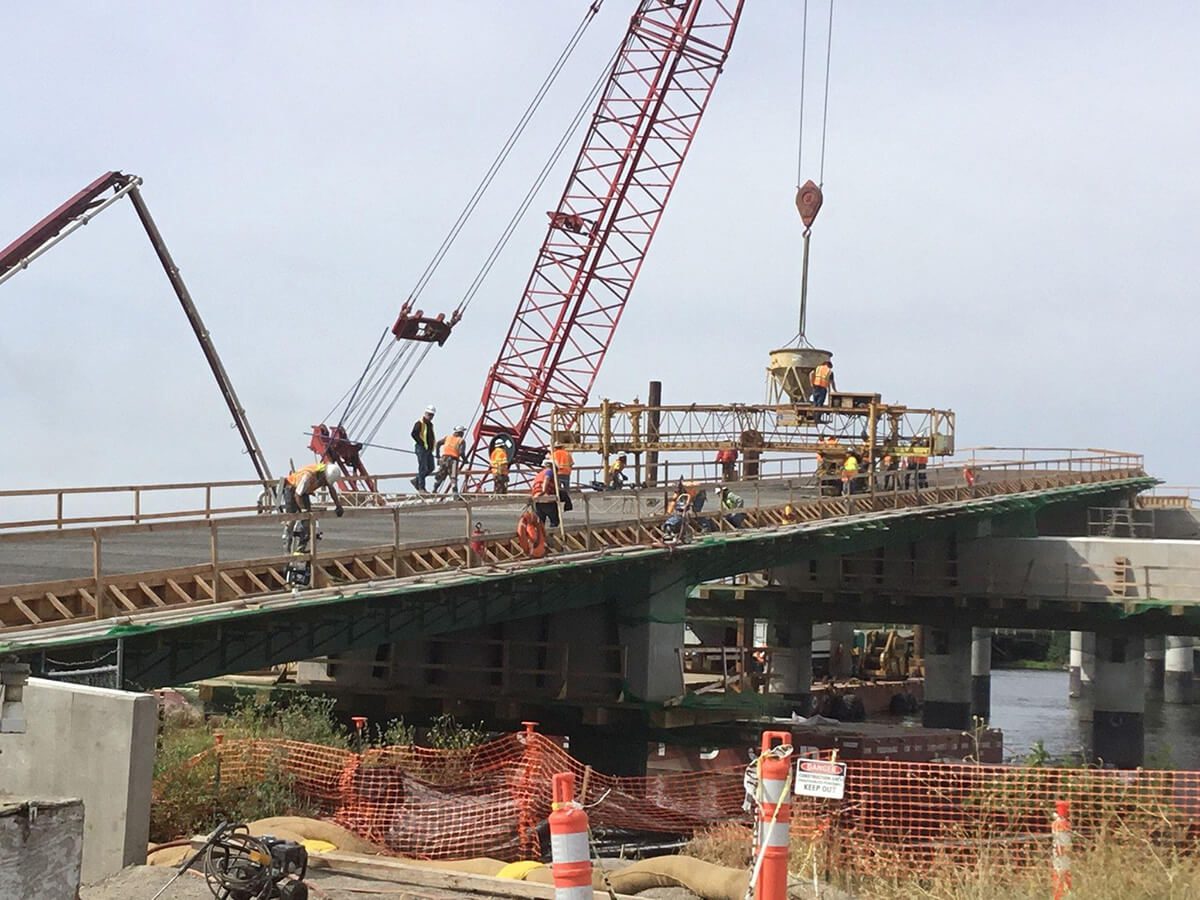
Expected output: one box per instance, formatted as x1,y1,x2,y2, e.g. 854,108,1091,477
0,454,1145,631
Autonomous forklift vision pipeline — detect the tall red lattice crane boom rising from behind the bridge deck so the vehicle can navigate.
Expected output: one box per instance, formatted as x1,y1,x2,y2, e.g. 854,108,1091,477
472,0,742,475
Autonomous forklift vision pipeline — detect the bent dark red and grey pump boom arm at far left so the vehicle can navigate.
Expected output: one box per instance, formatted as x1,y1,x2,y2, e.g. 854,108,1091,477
0,172,272,488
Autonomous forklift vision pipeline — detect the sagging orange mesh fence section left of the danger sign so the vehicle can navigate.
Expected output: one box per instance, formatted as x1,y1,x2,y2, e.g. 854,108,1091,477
176,733,750,859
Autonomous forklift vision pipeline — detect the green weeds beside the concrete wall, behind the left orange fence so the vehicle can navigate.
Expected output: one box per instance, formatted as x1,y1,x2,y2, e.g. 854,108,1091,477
150,694,488,842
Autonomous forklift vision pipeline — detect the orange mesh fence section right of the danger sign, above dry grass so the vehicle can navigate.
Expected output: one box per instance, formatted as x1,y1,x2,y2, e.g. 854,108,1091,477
793,761,1200,872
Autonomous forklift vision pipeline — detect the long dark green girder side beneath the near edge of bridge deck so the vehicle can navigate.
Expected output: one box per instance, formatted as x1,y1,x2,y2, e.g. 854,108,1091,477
9,478,1152,689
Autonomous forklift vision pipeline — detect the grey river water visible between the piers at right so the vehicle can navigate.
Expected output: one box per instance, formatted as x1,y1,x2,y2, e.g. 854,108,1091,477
991,670,1200,769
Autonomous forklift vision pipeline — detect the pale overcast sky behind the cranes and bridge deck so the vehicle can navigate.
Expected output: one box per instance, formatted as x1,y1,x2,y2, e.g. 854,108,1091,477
0,0,1200,487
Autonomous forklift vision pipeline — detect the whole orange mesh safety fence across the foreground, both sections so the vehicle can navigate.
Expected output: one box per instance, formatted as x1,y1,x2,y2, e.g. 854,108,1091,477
175,733,1200,872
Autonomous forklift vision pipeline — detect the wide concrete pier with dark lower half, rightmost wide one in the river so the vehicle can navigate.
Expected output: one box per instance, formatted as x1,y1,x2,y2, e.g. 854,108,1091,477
1092,635,1146,769
